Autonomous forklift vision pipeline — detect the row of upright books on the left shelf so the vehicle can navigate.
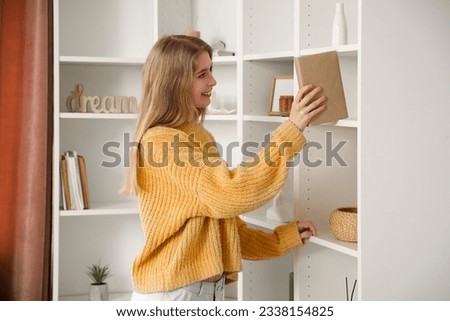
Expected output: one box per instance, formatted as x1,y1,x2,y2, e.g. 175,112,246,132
61,151,90,210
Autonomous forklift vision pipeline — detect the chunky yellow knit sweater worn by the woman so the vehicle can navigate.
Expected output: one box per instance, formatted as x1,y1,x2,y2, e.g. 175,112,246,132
132,121,305,293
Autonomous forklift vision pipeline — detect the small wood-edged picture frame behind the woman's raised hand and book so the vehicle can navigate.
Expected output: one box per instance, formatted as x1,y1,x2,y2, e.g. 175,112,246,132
269,75,294,116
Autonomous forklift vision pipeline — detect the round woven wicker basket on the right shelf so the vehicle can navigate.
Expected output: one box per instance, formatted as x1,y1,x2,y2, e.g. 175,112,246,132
328,207,358,242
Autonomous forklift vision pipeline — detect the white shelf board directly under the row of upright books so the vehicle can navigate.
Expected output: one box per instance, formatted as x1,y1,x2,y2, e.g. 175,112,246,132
59,202,139,217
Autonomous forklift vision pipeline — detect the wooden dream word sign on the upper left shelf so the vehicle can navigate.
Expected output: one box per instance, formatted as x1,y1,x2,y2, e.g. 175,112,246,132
66,83,138,113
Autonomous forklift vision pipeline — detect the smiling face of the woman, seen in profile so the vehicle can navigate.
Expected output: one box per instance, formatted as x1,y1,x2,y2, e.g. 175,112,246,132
191,51,217,108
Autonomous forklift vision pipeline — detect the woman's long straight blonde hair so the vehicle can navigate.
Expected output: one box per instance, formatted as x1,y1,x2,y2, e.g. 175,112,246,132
121,35,212,195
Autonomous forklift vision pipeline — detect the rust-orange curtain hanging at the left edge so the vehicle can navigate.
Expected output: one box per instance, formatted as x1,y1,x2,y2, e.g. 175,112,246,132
0,0,53,300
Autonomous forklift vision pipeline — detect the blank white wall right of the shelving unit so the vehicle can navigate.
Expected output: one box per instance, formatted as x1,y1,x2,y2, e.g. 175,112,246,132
360,0,450,300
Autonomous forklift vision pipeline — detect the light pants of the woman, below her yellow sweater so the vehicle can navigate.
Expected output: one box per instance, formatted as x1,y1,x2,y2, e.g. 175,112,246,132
131,277,225,301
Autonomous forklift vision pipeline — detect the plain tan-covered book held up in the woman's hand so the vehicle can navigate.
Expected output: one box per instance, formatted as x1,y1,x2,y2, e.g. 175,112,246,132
294,51,348,125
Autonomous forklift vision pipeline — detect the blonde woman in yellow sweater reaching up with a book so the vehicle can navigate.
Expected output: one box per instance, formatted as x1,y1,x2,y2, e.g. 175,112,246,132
123,35,326,300
